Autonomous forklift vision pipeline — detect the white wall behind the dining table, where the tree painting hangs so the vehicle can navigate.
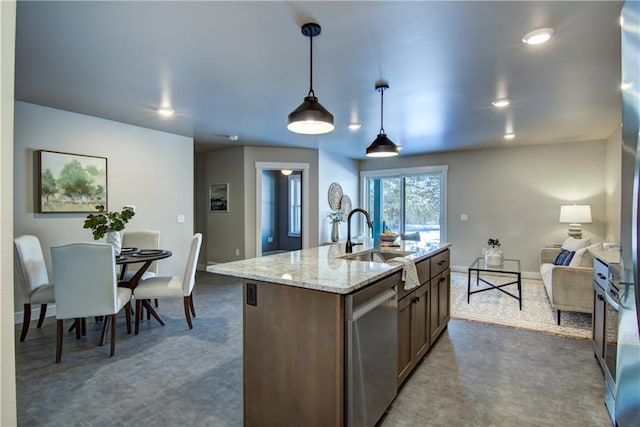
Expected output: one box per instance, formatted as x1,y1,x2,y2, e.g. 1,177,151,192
13,102,194,310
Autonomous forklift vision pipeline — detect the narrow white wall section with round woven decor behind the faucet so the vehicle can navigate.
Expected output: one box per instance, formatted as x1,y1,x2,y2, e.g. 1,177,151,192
318,150,360,243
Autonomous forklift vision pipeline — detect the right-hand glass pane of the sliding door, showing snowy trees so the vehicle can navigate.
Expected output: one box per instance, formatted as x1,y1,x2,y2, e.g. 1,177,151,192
403,174,442,243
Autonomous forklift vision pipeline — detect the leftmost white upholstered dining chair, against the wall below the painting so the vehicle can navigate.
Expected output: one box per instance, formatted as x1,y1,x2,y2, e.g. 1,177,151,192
13,235,55,341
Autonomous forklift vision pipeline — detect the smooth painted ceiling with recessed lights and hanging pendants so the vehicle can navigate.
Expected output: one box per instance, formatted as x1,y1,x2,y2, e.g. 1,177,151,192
15,1,622,159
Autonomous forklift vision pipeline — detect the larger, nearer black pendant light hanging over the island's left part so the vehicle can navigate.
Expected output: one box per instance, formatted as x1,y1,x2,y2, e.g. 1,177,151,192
287,23,334,135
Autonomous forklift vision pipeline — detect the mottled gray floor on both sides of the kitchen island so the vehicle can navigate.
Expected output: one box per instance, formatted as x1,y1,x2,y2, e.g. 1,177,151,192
16,272,611,427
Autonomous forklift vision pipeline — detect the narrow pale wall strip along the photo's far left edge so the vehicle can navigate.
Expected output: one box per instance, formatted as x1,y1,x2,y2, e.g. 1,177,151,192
0,0,17,426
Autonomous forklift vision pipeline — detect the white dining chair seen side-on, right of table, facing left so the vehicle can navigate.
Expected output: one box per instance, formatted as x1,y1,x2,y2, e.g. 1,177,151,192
133,233,202,334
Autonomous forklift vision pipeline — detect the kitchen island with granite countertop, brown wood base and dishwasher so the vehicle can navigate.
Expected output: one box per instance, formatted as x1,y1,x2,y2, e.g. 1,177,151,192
207,241,450,426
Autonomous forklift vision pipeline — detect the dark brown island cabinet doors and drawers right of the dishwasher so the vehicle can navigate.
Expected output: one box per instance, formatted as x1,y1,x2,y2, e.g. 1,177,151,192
398,249,451,387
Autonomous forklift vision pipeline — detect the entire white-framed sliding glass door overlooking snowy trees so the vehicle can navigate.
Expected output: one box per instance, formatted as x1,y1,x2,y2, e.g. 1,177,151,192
361,166,447,243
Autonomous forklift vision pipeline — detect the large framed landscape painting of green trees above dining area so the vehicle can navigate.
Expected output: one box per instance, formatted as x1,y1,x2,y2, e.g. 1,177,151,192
38,150,108,213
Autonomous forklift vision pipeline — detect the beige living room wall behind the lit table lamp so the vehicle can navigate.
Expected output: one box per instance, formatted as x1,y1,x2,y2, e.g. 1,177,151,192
361,141,607,273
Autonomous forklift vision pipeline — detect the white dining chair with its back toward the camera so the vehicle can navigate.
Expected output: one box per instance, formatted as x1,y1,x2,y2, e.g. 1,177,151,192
51,243,131,363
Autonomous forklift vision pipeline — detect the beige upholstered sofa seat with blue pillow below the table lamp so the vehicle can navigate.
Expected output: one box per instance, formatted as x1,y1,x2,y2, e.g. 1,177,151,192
540,237,601,325
